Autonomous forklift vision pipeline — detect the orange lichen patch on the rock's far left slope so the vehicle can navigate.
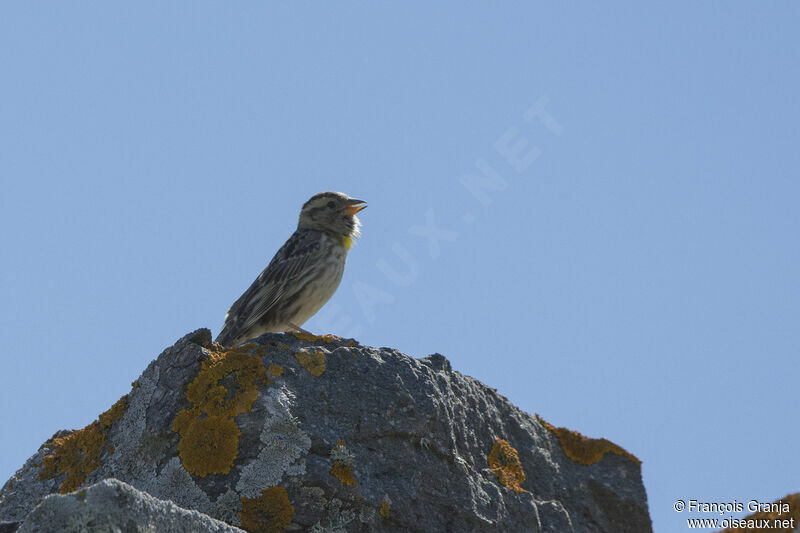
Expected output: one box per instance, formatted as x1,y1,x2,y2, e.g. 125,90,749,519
39,396,128,494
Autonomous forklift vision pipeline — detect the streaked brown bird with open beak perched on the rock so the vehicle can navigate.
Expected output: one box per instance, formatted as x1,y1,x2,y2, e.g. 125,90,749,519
217,192,367,346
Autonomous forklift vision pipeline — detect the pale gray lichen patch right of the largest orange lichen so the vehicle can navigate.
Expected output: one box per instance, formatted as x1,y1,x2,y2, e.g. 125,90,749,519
236,387,311,498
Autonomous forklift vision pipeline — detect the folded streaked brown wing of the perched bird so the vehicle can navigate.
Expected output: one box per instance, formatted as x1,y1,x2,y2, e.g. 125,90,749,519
220,230,322,338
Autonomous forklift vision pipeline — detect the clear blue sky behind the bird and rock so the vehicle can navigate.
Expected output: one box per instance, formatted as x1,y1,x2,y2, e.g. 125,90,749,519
0,1,800,532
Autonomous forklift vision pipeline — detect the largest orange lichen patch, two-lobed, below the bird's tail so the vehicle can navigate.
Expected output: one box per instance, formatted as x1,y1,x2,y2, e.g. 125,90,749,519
172,348,269,477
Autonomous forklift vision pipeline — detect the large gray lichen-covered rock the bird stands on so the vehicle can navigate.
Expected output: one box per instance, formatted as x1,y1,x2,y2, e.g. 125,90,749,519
0,329,651,533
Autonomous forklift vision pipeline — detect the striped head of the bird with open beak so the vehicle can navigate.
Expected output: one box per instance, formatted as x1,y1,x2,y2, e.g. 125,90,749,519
297,192,367,237
